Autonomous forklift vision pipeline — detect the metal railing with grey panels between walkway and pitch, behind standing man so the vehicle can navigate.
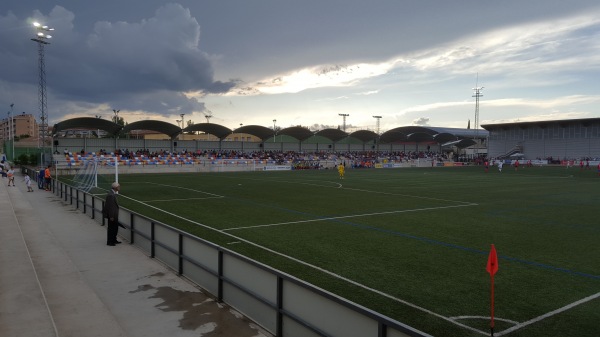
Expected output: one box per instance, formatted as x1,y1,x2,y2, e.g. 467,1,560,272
32,170,430,337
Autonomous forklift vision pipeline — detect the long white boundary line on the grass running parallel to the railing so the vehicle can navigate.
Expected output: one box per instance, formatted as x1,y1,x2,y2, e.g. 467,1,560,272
121,195,487,335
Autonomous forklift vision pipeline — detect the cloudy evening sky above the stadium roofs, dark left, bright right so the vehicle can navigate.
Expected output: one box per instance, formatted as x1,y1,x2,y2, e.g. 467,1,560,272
0,0,600,132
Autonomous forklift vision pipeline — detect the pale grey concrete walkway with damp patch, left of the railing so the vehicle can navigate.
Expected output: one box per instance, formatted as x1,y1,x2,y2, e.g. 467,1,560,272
0,174,270,337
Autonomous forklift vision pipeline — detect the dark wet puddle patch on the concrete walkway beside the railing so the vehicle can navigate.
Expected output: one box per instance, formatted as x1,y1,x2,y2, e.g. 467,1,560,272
130,280,267,337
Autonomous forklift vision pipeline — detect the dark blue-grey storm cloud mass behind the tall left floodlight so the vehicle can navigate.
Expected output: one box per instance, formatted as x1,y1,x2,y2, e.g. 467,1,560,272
0,4,235,117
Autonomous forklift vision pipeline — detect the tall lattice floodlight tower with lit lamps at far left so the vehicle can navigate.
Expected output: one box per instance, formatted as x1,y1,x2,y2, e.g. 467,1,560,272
31,22,54,165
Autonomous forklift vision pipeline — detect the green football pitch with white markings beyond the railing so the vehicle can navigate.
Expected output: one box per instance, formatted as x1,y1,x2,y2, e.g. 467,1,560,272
83,166,600,337
